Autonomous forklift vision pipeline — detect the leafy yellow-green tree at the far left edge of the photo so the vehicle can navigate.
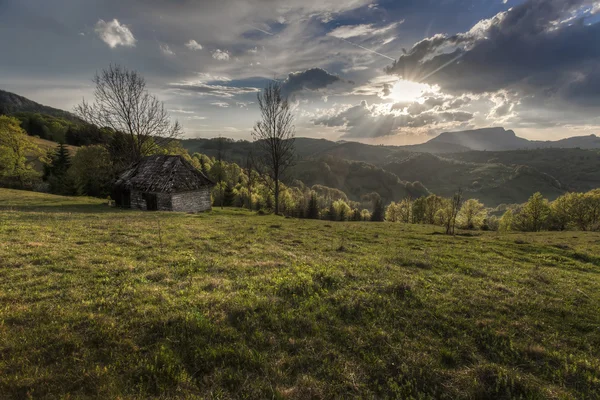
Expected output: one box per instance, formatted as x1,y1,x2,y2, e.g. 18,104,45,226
0,116,41,187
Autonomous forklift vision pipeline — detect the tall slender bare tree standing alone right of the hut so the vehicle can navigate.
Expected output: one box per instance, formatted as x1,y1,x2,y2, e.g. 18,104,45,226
252,81,295,214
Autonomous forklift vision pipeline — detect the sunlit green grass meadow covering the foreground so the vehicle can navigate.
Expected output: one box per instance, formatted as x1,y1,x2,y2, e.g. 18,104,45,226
0,190,600,399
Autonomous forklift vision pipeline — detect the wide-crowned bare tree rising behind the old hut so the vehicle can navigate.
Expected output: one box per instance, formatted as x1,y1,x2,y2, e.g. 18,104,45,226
75,65,181,162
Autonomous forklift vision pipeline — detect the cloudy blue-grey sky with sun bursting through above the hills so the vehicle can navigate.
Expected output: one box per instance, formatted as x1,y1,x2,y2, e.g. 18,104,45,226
0,0,600,145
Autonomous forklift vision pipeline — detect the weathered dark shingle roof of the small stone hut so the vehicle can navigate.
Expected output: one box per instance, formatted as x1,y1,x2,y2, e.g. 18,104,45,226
115,155,215,193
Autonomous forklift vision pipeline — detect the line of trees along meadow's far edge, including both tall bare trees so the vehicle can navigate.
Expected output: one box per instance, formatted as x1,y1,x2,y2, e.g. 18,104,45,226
0,65,600,234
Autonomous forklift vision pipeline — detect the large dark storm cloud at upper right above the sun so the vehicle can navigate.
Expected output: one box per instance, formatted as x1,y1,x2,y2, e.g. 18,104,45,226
387,0,600,102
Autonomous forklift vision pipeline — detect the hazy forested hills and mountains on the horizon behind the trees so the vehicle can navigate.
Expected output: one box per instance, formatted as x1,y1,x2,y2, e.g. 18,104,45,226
0,91,600,207
